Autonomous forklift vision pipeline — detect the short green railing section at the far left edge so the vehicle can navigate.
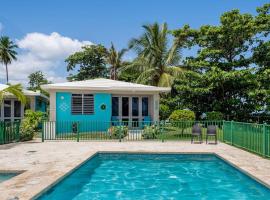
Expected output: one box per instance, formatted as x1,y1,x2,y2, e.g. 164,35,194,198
0,122,20,144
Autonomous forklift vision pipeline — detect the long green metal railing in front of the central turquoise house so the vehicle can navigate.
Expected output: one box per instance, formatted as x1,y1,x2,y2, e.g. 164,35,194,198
42,121,223,142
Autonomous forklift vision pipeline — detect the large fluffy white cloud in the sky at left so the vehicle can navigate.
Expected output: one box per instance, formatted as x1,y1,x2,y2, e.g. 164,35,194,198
0,32,93,85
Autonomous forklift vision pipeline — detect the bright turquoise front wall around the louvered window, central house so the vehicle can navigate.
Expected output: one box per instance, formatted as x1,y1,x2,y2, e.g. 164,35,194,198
56,92,112,133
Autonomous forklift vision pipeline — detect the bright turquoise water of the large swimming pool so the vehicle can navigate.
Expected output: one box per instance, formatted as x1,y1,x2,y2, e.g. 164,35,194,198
38,153,270,200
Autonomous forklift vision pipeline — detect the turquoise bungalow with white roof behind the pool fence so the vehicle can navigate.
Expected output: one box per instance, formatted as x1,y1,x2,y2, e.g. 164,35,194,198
41,78,170,134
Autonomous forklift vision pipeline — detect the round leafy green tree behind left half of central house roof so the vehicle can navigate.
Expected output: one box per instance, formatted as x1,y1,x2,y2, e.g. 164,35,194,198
65,45,108,81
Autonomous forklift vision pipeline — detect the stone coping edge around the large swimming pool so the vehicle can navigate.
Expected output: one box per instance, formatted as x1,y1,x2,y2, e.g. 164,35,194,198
31,151,270,200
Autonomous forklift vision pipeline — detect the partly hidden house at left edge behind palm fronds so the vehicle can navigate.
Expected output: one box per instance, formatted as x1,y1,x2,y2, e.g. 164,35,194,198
0,84,49,121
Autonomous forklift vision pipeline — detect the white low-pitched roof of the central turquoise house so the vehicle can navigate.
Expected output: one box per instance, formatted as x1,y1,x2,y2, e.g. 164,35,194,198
41,78,171,93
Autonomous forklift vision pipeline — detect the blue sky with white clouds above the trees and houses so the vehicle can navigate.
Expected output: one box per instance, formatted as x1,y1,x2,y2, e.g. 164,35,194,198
0,0,269,86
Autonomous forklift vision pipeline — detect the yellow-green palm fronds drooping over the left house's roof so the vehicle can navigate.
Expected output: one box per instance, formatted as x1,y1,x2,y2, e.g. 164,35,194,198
0,84,26,105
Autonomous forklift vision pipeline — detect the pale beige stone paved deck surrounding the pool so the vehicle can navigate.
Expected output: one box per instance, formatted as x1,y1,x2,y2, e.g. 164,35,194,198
0,141,270,200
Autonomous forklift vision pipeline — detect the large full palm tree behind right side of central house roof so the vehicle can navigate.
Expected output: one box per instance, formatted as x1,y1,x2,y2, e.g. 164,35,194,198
124,23,183,87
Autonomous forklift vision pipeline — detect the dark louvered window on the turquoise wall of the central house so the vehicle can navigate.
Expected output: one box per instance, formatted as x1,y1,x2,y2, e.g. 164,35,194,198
71,94,94,115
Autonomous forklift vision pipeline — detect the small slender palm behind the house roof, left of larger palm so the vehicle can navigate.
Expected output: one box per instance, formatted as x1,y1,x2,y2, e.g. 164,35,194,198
107,43,127,80
